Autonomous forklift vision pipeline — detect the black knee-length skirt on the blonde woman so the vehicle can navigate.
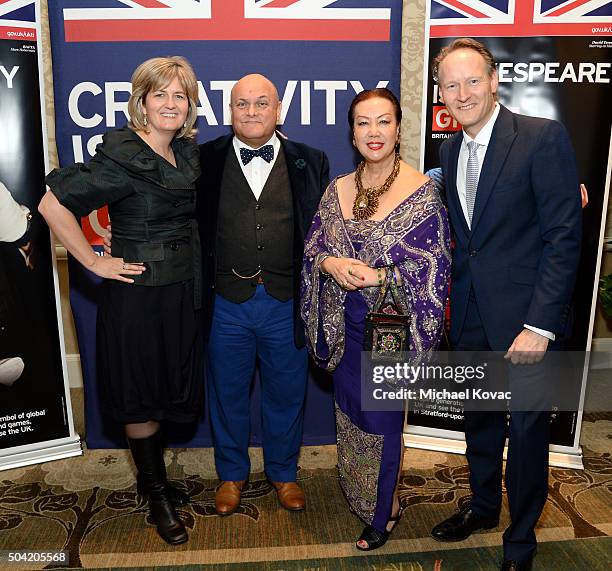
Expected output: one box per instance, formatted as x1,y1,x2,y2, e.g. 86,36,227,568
96,280,204,424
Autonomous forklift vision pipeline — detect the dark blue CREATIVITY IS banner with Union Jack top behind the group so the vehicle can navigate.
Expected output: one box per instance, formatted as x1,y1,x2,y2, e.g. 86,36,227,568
48,0,403,448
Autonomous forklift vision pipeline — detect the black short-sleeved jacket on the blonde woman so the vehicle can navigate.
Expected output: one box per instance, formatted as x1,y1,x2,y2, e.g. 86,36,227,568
46,128,200,305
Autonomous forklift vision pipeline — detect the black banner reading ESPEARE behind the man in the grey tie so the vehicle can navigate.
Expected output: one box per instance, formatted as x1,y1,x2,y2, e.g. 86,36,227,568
420,0,612,456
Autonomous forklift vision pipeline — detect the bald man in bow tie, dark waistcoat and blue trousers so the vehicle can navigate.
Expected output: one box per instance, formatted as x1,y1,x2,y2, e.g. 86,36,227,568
198,74,329,515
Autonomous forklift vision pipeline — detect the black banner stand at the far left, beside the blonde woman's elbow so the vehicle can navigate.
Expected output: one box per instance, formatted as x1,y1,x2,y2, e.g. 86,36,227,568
0,0,82,470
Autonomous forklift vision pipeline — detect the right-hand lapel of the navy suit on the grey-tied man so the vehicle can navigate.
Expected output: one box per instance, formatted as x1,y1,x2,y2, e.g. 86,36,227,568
472,106,516,233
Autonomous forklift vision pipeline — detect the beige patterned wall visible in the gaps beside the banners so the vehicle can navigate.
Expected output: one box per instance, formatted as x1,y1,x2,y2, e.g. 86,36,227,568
41,0,612,366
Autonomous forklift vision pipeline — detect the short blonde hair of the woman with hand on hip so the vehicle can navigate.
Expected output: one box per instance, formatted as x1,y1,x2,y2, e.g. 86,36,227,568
128,56,198,139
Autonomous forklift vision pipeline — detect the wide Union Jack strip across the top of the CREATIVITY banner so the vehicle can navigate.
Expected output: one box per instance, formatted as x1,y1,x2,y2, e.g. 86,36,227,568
63,0,391,42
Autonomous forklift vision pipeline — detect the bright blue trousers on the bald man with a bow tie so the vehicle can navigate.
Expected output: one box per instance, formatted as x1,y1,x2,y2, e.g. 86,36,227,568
207,285,308,482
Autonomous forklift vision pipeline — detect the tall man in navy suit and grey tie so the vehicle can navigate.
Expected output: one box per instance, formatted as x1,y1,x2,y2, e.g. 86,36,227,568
432,38,581,570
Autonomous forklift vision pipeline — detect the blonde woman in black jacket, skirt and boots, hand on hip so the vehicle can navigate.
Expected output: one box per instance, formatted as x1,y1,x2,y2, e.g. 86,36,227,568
39,56,203,545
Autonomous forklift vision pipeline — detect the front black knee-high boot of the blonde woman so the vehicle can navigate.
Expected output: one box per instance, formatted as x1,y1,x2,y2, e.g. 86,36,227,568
128,432,188,545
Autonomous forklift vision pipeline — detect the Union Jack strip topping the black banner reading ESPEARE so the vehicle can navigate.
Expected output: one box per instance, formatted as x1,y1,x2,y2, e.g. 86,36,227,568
430,0,612,38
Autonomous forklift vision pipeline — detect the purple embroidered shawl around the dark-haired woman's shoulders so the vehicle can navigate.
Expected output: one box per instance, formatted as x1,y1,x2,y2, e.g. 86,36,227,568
300,179,451,371
